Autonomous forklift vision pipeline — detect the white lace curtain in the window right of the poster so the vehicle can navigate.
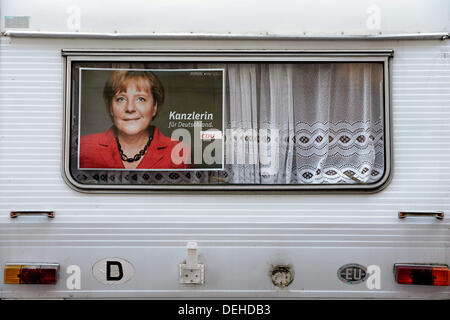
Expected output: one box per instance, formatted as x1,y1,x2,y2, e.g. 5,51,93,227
224,63,384,184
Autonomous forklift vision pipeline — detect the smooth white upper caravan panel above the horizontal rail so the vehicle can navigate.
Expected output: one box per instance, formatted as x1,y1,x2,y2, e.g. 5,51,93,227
1,0,450,35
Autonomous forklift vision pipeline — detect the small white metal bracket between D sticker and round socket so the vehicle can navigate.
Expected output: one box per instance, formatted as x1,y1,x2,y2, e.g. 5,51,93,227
180,242,205,284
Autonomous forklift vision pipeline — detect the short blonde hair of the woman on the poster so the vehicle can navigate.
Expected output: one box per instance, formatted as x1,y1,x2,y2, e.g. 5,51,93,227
103,70,164,119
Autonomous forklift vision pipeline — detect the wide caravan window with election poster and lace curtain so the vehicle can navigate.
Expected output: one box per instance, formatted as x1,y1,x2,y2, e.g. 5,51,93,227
65,54,390,190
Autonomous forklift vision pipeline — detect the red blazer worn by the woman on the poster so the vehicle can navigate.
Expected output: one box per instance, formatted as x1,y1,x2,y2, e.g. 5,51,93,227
80,127,192,170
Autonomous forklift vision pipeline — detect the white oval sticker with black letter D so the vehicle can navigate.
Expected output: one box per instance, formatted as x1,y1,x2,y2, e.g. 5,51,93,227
92,258,134,285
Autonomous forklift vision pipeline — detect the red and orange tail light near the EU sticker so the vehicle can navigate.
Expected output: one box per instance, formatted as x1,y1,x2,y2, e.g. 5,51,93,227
394,264,450,286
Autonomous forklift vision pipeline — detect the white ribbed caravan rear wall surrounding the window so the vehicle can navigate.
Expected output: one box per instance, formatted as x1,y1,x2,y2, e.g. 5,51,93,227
0,38,450,298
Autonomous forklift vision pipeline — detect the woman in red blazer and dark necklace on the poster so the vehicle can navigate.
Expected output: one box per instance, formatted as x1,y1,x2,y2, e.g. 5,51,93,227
79,70,191,170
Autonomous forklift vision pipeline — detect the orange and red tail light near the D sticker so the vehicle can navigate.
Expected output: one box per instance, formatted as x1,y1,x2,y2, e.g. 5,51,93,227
4,263,59,284
